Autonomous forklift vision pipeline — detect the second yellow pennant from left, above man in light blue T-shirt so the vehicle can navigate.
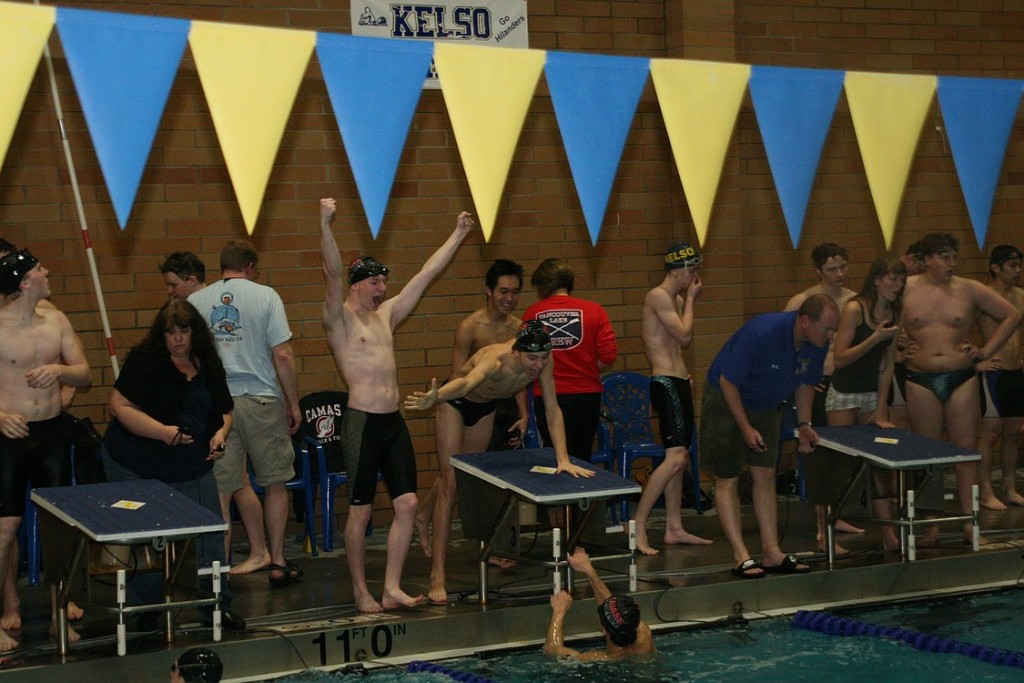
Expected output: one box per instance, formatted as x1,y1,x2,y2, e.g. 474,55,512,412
188,22,316,234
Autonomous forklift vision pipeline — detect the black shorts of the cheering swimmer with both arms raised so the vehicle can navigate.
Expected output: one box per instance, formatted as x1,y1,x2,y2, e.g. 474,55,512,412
341,408,416,505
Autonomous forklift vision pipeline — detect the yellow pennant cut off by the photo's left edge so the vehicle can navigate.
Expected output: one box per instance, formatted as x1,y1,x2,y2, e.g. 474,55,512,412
0,2,57,174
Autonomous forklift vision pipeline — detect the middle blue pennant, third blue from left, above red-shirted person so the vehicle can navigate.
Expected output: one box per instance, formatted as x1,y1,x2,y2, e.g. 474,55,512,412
544,52,650,245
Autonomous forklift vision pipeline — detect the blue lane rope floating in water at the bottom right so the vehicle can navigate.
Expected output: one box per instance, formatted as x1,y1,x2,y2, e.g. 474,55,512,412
793,609,1024,669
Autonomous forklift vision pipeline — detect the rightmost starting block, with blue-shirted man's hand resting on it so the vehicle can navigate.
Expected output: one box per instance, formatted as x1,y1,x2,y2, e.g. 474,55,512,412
807,425,981,569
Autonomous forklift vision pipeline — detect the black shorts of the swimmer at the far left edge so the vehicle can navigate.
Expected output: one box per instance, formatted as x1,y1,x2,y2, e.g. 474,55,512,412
0,416,71,517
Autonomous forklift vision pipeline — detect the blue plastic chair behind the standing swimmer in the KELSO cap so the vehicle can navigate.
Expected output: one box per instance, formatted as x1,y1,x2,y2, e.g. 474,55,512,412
601,372,703,519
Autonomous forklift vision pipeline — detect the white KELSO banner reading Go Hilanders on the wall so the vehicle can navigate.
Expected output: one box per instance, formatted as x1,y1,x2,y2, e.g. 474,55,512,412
349,0,529,88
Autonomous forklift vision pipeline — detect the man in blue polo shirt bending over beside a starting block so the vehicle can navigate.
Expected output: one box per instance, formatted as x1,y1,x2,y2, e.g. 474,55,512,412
700,294,839,579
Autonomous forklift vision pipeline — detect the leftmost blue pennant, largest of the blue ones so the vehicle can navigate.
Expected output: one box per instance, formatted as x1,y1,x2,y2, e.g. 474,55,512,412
56,7,190,229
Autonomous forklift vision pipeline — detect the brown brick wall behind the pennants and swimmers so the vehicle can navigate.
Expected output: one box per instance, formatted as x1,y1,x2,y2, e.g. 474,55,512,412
0,0,1024,524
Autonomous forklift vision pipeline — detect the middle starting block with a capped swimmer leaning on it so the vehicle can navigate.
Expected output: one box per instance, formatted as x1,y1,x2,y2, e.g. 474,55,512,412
451,449,640,604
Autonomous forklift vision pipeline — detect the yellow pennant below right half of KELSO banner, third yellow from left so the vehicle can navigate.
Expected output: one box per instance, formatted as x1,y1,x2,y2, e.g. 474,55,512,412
434,43,545,242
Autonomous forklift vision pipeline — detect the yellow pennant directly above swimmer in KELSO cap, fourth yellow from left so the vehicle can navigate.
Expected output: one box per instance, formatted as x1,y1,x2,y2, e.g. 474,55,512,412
650,59,751,245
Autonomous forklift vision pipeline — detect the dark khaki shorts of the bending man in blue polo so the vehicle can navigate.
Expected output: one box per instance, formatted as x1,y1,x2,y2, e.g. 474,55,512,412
699,383,780,479
